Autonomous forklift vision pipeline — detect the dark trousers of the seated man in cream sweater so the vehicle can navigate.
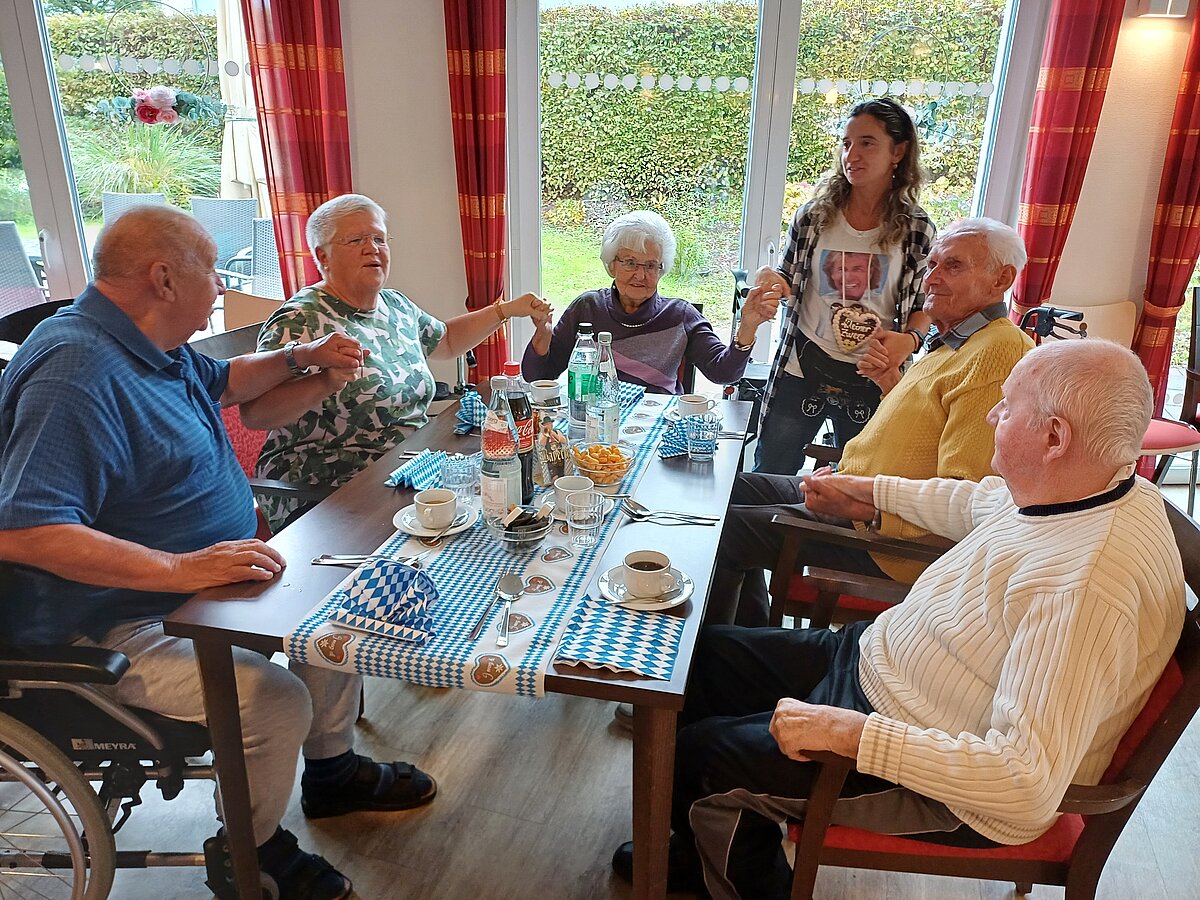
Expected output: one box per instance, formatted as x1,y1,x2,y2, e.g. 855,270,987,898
671,622,996,900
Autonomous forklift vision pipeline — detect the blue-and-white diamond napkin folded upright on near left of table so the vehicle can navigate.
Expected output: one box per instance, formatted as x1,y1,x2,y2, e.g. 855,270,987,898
329,559,438,646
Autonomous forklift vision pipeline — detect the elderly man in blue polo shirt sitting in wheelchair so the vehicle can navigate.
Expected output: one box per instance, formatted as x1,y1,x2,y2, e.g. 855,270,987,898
0,206,437,900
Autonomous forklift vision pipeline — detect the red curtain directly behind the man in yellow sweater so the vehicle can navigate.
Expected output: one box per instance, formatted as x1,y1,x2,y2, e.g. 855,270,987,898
1012,0,1124,322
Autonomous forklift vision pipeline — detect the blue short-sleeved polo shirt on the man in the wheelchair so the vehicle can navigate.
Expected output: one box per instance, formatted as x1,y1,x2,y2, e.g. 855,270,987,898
0,286,256,643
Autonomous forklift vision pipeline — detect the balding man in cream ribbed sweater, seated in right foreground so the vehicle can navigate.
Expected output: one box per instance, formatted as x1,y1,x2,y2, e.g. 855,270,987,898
613,340,1184,900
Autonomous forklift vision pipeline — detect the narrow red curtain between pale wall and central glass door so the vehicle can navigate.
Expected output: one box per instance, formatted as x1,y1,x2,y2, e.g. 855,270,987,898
444,0,509,382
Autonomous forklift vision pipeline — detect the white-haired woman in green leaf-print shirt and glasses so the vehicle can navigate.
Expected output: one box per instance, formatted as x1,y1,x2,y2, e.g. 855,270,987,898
242,193,551,529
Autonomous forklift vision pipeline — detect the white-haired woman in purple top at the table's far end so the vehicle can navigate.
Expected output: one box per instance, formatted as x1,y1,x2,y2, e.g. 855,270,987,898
521,210,780,394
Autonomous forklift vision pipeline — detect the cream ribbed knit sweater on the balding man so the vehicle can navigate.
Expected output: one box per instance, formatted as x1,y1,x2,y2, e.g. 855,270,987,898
858,468,1184,844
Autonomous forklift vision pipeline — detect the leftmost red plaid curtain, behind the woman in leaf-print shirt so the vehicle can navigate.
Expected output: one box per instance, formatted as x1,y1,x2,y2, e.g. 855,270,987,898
241,0,352,296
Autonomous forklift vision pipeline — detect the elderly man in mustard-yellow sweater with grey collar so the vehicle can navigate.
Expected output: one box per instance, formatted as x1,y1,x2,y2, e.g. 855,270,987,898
706,218,1033,626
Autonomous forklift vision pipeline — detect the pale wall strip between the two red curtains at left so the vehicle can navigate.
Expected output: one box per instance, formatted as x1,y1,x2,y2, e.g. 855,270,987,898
341,0,467,382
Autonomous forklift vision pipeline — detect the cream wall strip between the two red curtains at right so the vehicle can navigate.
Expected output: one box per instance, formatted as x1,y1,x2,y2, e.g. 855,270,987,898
1051,1,1200,324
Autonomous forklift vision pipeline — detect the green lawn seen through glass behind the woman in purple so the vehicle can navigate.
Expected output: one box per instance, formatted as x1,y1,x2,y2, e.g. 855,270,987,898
541,226,733,337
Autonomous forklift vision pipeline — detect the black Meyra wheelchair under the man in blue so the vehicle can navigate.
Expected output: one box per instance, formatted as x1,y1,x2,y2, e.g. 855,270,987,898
0,646,277,900
